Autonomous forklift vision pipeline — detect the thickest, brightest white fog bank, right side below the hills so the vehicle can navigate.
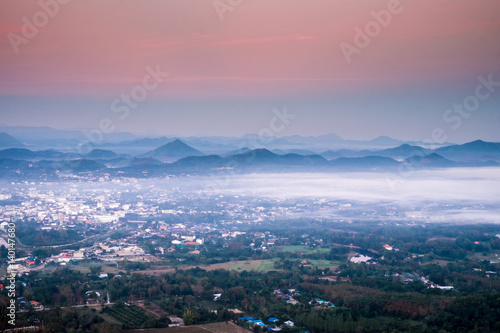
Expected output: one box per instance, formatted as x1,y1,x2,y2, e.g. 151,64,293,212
199,168,500,204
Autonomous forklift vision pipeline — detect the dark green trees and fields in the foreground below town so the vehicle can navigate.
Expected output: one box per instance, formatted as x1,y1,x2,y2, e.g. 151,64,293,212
0,221,500,333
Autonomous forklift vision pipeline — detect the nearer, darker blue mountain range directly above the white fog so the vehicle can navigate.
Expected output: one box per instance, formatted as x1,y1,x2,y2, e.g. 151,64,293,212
0,139,500,178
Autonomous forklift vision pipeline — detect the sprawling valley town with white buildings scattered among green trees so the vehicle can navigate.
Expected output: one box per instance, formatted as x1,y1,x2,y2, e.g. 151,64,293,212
0,177,500,332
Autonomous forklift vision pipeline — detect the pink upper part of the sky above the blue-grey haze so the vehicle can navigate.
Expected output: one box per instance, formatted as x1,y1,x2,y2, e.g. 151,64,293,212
0,0,500,98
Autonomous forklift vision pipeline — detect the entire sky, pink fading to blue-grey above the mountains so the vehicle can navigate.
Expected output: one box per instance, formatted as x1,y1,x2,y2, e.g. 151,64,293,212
0,0,500,142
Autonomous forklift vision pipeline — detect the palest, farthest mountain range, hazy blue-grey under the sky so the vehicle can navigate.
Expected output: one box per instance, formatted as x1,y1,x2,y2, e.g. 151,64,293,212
0,126,449,155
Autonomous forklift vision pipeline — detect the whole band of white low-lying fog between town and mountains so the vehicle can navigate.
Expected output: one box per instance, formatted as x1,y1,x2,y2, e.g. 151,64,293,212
0,168,500,223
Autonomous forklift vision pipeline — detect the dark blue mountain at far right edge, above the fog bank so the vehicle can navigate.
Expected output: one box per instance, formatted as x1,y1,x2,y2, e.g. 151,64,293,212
434,140,500,162
